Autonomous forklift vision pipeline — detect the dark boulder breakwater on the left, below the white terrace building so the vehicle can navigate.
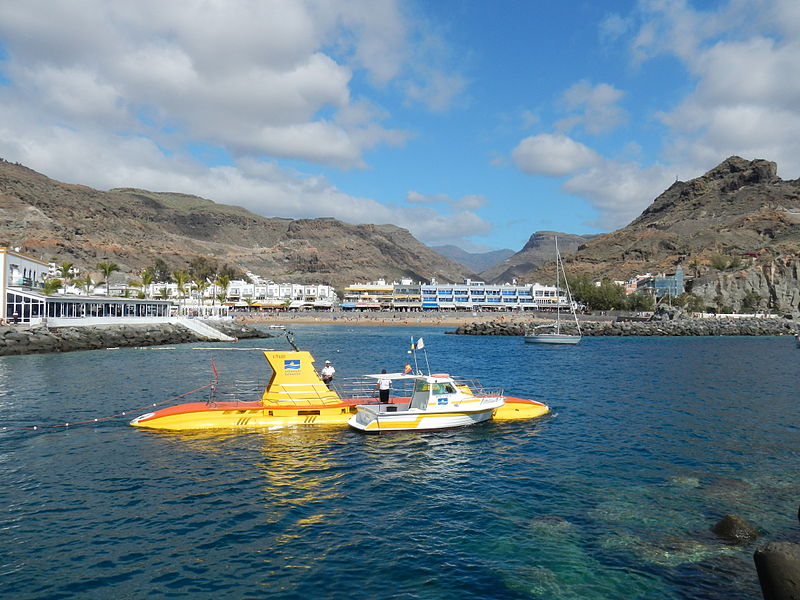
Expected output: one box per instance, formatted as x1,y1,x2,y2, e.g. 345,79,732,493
0,321,272,356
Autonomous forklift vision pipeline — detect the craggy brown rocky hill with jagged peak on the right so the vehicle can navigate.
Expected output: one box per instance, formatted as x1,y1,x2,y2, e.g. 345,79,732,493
520,156,800,312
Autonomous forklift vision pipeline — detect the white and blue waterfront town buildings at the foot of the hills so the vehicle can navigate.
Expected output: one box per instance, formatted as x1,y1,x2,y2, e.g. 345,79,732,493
0,247,684,324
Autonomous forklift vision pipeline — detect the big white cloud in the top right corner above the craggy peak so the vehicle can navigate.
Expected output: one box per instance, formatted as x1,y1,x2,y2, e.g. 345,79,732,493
634,0,800,178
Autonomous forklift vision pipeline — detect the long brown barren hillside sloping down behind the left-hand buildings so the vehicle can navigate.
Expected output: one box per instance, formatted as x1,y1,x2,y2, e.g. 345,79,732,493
0,161,471,287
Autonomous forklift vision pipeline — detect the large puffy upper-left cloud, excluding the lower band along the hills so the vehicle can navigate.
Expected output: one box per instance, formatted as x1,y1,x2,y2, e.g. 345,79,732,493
0,0,463,168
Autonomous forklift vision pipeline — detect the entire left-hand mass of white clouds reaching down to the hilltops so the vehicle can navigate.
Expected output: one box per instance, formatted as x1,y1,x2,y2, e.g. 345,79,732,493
0,0,490,246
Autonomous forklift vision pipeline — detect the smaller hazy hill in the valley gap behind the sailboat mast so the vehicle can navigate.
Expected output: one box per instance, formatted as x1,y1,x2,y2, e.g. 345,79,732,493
478,231,595,283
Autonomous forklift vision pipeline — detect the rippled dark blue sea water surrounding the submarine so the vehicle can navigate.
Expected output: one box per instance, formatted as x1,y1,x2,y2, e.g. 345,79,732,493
0,325,800,600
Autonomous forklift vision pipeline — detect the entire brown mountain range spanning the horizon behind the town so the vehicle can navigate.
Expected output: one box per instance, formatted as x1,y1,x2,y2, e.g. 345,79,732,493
0,156,800,312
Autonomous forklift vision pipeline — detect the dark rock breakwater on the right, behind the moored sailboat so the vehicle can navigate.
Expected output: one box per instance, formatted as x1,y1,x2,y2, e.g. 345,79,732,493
449,318,798,337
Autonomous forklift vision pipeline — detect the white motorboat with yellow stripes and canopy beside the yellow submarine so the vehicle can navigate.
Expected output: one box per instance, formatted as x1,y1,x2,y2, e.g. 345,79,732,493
347,373,505,433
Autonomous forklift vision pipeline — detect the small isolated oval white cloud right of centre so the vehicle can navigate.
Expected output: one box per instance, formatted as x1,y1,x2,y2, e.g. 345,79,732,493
511,133,600,177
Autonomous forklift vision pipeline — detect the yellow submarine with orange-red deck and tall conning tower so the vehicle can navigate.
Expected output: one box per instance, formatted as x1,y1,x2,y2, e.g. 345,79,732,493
130,349,550,431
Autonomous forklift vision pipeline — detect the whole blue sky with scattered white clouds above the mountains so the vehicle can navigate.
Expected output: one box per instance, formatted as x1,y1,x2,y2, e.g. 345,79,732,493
0,0,800,251
